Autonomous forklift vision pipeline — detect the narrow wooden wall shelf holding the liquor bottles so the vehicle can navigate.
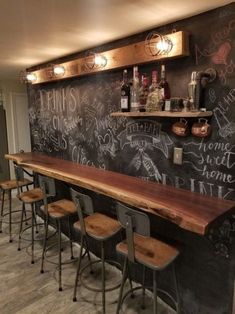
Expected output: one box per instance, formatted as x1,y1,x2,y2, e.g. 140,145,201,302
111,111,213,118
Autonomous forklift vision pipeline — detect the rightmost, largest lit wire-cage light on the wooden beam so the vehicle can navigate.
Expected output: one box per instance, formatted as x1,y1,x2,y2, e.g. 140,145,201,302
145,32,173,56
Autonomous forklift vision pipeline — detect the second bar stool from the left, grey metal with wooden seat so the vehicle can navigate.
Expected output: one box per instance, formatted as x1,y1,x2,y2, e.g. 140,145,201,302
14,164,43,264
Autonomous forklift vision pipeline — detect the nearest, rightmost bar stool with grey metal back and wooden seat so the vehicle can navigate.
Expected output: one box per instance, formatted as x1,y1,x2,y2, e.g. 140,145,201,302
116,203,179,314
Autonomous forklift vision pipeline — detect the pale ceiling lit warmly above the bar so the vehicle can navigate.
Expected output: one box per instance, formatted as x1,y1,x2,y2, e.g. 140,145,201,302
0,0,231,79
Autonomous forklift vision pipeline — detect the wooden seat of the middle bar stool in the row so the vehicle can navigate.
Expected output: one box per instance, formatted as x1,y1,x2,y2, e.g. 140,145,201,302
48,199,77,219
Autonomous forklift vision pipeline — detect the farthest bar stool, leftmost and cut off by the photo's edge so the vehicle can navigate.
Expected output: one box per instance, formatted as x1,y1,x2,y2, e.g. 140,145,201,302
0,167,33,242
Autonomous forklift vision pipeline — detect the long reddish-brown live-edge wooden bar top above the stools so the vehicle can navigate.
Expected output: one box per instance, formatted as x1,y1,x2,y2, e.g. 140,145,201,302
5,152,235,235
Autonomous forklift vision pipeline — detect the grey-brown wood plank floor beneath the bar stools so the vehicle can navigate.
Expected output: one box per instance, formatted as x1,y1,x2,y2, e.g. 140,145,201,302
0,200,175,314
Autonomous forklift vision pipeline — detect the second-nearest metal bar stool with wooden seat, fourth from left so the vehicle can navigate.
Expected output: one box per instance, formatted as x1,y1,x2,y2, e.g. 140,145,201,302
71,189,121,314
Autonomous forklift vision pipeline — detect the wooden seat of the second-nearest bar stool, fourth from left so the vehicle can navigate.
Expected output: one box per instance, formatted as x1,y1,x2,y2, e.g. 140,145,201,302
74,213,121,240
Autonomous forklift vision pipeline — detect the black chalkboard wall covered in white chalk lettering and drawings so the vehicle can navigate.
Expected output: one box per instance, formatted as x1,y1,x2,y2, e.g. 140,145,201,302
28,3,235,314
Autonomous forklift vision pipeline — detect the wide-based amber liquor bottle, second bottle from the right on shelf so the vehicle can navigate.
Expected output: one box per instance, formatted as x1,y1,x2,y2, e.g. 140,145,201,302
146,71,161,112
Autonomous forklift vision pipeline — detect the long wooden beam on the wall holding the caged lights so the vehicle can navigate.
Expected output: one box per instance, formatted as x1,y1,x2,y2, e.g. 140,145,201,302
29,31,189,84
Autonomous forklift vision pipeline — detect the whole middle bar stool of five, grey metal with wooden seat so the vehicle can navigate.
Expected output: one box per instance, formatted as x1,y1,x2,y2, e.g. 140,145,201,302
39,175,77,291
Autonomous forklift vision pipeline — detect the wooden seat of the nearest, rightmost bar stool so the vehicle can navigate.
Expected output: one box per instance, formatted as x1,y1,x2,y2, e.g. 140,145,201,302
116,233,179,270
